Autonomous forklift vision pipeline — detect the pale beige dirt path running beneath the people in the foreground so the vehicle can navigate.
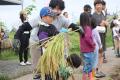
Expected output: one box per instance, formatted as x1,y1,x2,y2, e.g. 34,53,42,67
14,48,120,80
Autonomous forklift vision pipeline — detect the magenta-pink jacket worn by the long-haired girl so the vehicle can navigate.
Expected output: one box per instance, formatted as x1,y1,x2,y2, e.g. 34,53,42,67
80,26,95,53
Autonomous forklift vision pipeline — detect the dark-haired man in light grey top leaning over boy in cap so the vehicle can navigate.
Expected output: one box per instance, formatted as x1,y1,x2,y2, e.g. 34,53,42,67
20,0,81,79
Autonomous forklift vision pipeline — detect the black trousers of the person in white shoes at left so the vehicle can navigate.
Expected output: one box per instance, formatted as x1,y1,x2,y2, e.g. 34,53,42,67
19,39,29,62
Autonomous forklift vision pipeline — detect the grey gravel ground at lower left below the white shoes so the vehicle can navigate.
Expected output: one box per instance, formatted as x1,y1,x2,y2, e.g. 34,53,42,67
0,60,32,78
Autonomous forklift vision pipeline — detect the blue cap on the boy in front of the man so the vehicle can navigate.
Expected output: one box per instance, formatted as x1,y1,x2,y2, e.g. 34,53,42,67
40,7,55,17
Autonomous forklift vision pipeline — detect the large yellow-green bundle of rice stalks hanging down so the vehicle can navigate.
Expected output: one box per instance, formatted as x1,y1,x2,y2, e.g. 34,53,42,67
37,33,70,80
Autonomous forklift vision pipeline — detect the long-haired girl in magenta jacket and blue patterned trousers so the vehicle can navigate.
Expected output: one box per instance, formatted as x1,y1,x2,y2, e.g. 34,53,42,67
80,13,95,80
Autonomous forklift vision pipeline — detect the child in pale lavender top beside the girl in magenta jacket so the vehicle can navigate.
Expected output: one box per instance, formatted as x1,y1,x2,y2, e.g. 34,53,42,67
91,19,105,77
